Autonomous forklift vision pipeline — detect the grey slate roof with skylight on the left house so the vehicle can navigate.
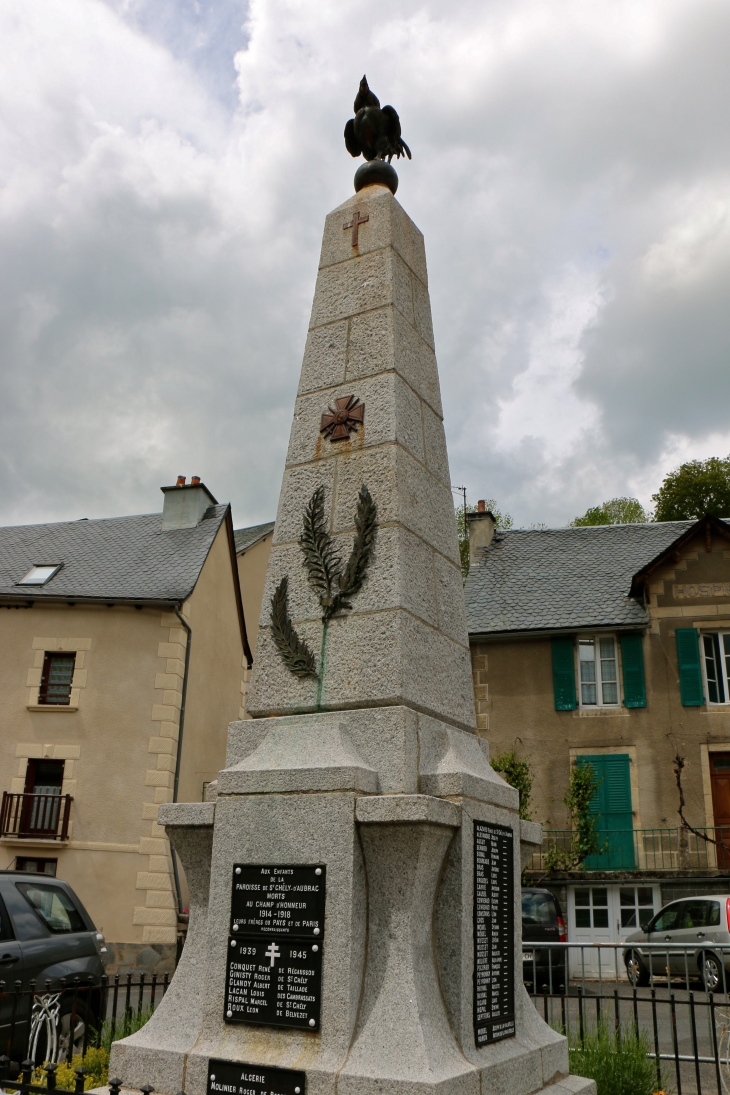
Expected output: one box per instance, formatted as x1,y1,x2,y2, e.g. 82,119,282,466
0,506,228,601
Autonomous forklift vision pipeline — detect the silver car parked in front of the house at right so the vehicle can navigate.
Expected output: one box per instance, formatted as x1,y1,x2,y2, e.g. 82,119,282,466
624,894,730,992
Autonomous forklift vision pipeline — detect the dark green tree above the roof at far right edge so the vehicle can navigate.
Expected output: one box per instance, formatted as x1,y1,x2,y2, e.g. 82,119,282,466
651,457,730,521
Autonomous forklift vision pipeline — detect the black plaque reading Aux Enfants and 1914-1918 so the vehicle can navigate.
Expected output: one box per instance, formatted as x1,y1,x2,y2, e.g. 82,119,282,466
231,863,327,938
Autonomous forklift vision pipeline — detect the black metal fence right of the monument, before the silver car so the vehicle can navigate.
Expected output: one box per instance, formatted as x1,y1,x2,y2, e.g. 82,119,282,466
523,943,730,1095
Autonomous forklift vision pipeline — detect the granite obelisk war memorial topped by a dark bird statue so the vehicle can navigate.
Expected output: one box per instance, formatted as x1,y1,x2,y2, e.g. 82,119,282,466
111,79,595,1095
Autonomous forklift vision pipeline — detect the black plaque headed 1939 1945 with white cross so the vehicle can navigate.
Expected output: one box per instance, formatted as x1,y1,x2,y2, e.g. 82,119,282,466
223,936,322,1030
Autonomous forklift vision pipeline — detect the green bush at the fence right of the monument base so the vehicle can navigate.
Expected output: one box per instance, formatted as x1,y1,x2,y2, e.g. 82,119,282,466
568,1024,661,1095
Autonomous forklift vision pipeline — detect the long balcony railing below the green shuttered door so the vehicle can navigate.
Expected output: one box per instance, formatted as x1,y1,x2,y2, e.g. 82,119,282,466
528,826,730,872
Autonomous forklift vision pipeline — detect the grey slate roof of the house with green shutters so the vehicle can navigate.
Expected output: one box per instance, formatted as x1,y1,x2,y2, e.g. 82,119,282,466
464,521,696,635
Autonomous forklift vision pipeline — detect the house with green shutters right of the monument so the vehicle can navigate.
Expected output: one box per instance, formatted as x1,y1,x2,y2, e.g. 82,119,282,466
465,504,730,963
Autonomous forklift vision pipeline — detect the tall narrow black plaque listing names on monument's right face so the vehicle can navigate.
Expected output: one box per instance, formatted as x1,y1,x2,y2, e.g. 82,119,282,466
474,820,515,1048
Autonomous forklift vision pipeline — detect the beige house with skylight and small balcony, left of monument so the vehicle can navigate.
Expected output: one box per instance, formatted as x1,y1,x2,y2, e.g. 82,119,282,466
0,477,251,972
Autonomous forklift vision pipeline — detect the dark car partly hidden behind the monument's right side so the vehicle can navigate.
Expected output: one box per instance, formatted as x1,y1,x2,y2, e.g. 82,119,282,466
522,888,568,992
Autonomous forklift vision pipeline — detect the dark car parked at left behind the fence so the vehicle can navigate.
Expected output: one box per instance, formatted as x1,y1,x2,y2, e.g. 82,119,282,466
0,871,106,1063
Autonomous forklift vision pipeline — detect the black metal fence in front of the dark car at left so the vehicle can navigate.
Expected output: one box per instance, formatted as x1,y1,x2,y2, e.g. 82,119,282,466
0,973,170,1068
